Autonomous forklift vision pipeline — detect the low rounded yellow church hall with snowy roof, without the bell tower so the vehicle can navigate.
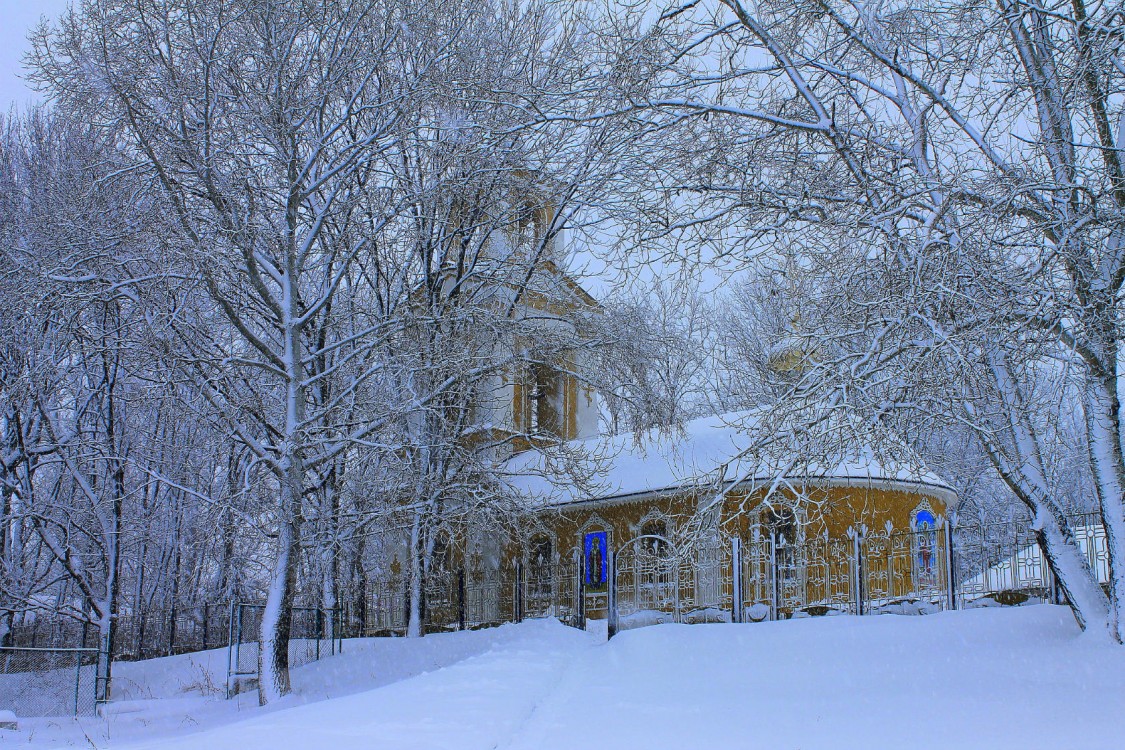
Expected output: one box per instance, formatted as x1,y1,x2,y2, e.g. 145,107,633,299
506,413,956,627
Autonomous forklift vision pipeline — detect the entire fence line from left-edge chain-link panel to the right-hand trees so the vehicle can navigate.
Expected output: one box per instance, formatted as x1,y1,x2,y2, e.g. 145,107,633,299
0,514,1109,716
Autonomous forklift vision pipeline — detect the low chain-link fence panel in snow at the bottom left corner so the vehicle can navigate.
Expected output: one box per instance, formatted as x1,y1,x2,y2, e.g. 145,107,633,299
0,647,101,716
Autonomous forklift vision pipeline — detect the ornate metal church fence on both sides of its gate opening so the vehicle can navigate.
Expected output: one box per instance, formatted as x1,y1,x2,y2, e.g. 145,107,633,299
363,516,1108,635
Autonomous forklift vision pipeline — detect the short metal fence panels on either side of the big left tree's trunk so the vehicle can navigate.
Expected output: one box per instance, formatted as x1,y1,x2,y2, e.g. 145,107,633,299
226,602,343,698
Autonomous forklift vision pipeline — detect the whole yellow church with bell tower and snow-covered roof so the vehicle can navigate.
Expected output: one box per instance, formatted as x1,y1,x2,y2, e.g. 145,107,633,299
368,215,957,632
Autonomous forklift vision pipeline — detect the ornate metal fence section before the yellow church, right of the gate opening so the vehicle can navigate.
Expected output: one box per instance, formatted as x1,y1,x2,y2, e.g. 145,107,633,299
606,514,1109,633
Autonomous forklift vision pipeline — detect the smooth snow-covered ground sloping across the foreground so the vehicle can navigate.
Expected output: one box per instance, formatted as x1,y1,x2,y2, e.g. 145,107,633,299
0,605,1125,750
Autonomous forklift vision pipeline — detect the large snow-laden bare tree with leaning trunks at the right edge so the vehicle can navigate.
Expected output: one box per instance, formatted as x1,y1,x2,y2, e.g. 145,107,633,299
603,0,1125,641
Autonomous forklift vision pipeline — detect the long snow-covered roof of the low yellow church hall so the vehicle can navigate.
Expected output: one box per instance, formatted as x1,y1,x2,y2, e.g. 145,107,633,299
504,412,955,505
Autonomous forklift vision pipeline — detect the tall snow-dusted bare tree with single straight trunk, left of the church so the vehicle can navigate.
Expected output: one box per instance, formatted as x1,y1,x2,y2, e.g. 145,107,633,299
30,2,432,704
